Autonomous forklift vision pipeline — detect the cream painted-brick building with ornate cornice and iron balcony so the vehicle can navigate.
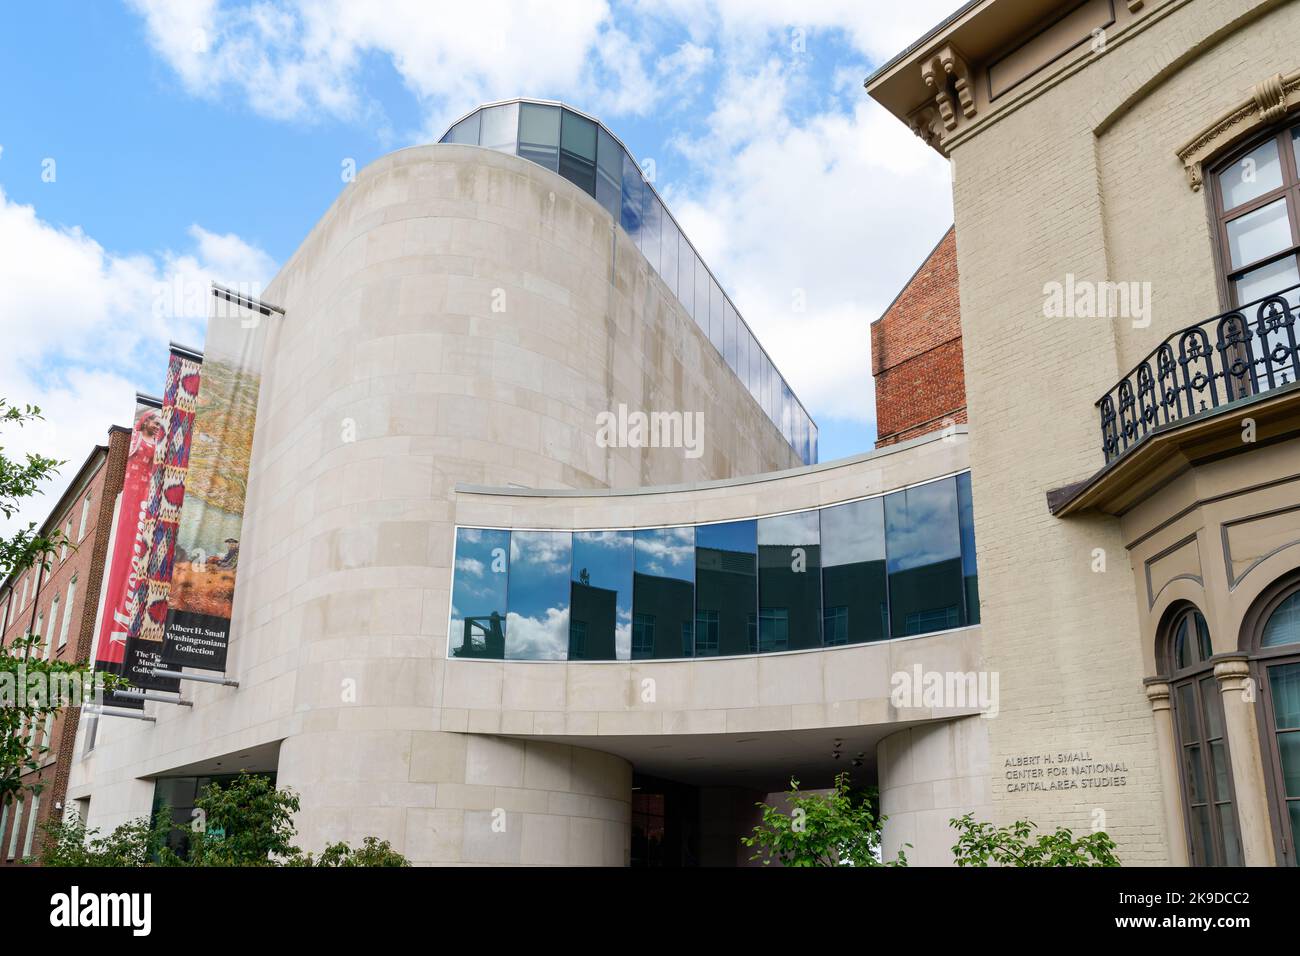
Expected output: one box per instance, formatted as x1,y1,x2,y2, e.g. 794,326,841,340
867,0,1300,864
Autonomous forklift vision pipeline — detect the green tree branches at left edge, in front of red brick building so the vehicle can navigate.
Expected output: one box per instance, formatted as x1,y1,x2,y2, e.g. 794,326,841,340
0,398,125,827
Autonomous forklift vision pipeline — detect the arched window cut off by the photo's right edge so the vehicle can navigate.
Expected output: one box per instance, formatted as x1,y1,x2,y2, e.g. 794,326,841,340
1247,575,1300,866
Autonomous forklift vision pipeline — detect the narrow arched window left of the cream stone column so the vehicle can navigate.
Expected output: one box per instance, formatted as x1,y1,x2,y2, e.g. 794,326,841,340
1164,604,1243,866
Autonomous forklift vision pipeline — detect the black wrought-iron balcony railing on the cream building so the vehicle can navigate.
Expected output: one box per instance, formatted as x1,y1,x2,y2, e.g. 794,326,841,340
1097,285,1300,464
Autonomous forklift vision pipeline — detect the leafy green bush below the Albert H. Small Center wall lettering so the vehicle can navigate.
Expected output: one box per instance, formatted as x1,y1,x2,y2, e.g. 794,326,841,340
948,813,1119,866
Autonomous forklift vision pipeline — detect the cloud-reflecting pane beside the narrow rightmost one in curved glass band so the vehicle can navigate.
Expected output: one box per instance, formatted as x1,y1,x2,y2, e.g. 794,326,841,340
885,479,966,637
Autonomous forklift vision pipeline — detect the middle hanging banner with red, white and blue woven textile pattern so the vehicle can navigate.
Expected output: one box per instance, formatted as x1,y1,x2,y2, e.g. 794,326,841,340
126,345,203,691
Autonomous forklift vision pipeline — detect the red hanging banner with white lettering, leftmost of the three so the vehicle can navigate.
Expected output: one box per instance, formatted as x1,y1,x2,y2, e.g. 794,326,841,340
95,395,163,706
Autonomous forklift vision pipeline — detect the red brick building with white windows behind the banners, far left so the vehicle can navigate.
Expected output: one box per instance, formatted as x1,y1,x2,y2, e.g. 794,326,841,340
0,425,131,866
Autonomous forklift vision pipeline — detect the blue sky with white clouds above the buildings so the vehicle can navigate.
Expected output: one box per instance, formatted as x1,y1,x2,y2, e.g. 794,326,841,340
0,0,957,530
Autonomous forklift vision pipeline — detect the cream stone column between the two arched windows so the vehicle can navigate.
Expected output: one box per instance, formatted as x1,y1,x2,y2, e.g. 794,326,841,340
1214,654,1275,866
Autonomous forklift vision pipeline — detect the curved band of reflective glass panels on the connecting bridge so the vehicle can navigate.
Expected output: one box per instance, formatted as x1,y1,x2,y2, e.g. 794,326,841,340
449,473,980,661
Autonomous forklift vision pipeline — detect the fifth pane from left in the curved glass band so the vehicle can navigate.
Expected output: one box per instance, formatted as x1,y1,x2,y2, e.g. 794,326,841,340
696,522,758,657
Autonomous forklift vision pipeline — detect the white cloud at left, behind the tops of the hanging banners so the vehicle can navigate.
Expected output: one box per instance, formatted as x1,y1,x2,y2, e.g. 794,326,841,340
0,189,274,535
